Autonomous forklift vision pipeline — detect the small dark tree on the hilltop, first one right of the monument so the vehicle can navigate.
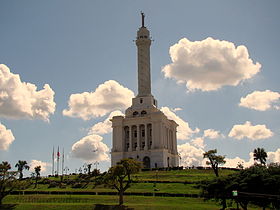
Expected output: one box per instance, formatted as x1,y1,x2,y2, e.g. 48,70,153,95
203,149,226,177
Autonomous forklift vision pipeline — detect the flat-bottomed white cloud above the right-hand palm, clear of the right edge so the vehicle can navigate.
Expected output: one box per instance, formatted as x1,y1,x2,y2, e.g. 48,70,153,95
228,121,273,140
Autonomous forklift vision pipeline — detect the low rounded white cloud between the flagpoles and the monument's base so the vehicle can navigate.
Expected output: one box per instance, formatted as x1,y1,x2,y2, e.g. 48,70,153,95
71,134,109,161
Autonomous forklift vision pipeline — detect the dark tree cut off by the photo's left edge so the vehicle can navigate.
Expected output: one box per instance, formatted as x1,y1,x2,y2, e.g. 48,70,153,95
0,161,18,205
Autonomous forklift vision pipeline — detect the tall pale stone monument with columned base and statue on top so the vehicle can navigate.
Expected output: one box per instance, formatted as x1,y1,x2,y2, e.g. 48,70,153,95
111,13,179,168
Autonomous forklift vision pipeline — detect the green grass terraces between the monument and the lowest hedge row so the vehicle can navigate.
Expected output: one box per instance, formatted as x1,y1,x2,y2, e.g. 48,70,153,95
23,169,235,194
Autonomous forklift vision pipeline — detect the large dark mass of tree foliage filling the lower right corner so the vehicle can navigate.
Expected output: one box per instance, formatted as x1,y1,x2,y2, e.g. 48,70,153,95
200,164,280,209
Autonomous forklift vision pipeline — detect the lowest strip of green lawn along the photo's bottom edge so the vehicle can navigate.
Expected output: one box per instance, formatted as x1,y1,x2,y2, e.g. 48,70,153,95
4,195,219,210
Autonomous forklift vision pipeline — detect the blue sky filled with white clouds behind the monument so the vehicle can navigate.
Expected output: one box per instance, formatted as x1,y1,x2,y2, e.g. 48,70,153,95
0,0,280,175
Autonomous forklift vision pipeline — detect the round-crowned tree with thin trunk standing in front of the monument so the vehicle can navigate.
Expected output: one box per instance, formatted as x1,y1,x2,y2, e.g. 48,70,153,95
104,159,141,205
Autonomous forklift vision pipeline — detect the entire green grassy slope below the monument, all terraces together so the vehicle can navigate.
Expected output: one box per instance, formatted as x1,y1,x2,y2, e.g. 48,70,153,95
4,169,256,210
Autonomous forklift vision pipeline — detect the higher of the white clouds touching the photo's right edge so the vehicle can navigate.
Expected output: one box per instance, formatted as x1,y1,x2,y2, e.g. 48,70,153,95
239,90,280,111
